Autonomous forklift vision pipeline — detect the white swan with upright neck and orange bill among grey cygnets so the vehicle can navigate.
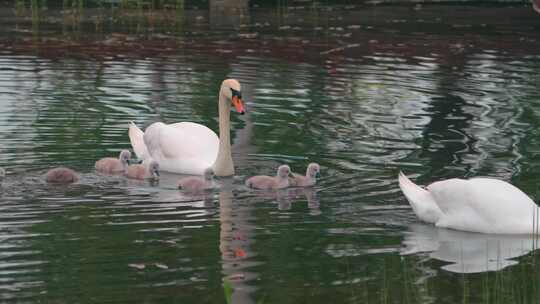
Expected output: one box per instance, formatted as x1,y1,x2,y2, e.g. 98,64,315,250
129,79,244,176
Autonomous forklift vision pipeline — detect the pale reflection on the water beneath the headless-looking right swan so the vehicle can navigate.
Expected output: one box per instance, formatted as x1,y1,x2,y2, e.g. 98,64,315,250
401,224,535,273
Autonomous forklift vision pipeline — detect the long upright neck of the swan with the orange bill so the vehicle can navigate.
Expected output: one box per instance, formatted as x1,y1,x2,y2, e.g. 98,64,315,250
213,87,234,176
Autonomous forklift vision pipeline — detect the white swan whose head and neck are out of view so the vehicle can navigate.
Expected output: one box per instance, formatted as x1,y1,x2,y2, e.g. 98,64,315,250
398,172,540,234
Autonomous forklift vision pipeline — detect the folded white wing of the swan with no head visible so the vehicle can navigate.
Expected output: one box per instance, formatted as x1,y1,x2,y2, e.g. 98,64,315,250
428,178,536,233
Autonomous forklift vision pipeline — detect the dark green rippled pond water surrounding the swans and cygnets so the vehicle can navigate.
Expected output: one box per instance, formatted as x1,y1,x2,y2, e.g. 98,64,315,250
0,2,540,303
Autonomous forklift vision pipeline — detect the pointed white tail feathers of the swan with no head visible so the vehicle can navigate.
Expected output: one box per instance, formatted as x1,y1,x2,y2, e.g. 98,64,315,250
398,172,443,223
